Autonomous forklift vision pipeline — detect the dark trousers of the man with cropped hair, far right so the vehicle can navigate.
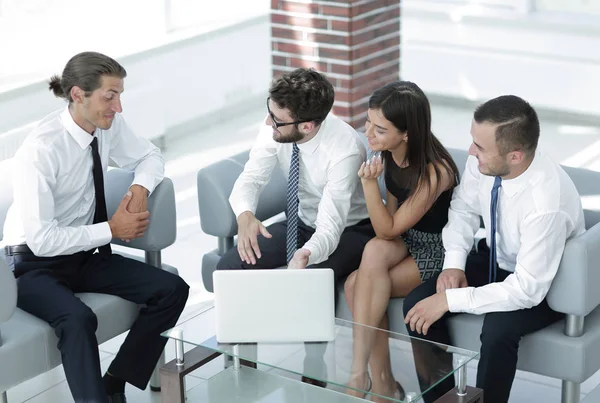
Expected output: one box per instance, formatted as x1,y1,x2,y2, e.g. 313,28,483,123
403,240,563,403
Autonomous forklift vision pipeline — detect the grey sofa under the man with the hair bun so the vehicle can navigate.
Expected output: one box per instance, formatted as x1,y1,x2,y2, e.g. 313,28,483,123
0,169,178,403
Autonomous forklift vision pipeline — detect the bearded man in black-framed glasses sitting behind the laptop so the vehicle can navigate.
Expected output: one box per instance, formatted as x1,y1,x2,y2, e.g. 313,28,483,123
217,68,375,288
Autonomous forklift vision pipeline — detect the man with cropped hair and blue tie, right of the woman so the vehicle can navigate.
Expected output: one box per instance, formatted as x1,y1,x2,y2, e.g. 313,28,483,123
404,95,585,403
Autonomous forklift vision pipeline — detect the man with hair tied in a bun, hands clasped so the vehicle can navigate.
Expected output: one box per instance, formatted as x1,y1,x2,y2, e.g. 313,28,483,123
4,52,189,403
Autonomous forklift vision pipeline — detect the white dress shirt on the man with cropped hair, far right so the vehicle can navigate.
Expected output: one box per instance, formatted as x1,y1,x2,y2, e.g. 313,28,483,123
442,151,585,314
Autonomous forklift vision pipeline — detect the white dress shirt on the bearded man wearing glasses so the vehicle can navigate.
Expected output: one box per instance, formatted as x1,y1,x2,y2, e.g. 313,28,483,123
229,113,368,264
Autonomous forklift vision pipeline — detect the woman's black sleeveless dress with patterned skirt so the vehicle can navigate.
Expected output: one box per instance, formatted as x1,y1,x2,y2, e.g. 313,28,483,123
382,152,452,281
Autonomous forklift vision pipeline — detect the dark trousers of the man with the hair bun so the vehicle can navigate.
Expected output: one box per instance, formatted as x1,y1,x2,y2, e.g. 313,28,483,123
6,252,189,403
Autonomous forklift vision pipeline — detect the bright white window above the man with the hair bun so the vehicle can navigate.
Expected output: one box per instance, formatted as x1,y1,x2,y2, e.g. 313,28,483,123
0,0,270,92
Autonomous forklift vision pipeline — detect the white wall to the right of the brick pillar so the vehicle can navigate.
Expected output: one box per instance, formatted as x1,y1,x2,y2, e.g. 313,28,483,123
400,0,600,117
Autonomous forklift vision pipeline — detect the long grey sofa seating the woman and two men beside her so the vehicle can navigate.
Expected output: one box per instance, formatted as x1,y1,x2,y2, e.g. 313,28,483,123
197,149,600,403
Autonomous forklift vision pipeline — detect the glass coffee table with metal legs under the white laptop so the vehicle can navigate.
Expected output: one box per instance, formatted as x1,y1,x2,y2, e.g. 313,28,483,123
160,303,483,403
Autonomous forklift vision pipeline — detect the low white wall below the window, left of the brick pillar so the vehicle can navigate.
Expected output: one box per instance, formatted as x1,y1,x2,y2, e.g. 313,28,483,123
0,15,271,160
